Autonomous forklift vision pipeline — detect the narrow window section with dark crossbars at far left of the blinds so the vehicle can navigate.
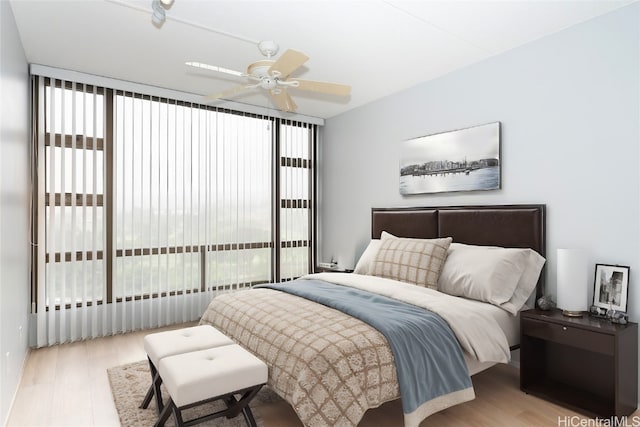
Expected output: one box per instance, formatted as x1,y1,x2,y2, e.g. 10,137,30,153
44,82,105,306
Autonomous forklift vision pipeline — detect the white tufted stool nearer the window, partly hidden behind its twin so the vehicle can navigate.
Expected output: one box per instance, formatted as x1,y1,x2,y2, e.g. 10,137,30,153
140,325,235,414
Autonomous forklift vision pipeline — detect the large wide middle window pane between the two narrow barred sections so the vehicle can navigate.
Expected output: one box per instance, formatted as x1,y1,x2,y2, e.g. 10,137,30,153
113,93,273,298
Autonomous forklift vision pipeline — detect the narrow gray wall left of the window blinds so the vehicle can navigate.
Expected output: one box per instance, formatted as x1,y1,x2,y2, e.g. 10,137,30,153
0,1,30,425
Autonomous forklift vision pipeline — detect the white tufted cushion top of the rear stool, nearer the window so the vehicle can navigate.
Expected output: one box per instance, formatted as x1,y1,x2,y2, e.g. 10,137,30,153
144,325,235,366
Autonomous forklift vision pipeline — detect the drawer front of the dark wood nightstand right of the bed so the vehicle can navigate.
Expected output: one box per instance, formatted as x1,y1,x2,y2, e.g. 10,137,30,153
521,319,615,355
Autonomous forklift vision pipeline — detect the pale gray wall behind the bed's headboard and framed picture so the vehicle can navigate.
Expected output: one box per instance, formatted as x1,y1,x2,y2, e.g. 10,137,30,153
320,3,640,320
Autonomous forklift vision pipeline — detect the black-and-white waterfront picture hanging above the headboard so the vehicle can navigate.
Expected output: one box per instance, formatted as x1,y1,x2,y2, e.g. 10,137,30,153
399,122,502,196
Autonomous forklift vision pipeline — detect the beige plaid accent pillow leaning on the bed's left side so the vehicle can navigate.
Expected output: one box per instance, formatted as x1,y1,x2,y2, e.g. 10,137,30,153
371,234,452,289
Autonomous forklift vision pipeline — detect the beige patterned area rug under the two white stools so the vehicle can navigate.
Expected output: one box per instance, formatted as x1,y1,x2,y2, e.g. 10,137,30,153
107,360,281,427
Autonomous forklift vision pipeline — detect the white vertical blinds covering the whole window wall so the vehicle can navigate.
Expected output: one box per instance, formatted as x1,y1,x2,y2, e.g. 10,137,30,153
32,76,317,346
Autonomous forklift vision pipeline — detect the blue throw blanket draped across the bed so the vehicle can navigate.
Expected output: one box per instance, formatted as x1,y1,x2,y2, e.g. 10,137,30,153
260,280,473,419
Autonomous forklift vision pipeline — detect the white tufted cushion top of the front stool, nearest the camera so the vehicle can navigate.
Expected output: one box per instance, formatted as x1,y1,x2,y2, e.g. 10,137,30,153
158,344,267,407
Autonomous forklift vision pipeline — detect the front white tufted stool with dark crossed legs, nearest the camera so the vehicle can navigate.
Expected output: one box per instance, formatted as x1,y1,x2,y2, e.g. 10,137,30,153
156,344,267,427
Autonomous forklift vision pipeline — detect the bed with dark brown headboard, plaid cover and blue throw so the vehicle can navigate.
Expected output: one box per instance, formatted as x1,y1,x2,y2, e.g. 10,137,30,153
201,205,545,427
